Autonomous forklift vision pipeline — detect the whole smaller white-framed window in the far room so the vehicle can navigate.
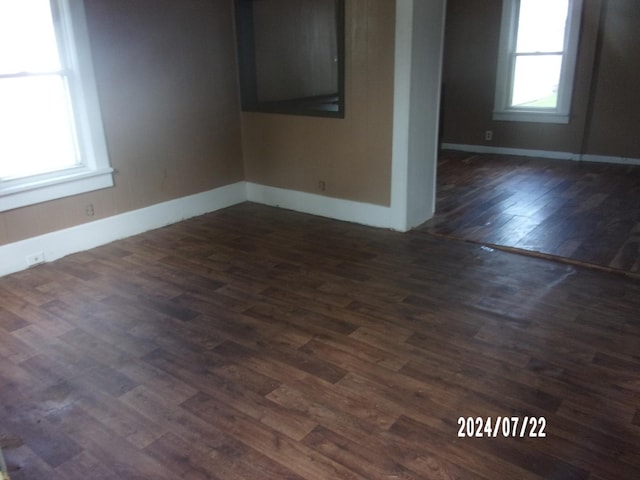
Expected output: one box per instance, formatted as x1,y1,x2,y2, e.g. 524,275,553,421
493,0,582,123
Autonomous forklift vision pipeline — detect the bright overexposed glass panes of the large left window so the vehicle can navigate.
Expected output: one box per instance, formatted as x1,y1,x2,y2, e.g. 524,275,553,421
0,0,78,180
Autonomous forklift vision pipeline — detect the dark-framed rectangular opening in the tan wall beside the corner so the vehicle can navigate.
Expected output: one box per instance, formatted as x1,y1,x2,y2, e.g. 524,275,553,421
235,0,344,117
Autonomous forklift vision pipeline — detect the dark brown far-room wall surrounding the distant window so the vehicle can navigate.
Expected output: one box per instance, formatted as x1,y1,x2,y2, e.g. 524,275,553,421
442,0,640,158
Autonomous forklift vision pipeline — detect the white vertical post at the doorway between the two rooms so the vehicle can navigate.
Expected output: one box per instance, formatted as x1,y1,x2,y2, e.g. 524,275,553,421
391,0,446,231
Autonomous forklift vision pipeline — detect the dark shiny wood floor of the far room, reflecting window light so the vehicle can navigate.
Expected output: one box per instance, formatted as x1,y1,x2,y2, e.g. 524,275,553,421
426,151,640,274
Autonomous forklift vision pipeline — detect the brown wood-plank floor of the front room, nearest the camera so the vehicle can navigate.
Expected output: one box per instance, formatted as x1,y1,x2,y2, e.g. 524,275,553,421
0,203,640,480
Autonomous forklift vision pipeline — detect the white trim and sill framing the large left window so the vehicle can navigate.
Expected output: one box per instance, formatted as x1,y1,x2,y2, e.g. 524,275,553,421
0,0,113,211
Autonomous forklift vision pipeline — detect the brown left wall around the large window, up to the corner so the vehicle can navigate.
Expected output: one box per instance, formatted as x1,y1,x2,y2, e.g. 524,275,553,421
0,0,244,244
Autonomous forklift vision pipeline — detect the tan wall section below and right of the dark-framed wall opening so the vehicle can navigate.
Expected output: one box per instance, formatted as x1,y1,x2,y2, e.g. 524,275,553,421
242,0,395,205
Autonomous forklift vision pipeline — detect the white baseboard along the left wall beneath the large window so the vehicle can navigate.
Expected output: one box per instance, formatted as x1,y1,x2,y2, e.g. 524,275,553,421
0,182,247,276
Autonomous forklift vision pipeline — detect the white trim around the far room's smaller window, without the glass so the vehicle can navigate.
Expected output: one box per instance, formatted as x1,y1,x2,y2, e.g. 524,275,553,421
493,0,583,124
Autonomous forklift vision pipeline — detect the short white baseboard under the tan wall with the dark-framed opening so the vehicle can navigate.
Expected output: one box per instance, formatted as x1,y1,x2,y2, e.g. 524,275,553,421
247,183,395,228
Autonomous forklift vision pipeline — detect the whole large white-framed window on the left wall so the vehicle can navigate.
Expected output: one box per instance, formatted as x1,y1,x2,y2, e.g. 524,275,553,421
0,0,113,211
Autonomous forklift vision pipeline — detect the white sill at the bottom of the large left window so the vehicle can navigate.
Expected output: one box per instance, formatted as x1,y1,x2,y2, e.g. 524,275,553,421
0,168,113,212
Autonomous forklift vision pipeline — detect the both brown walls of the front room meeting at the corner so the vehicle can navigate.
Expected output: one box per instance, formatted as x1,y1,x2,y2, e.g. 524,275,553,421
0,0,395,245
